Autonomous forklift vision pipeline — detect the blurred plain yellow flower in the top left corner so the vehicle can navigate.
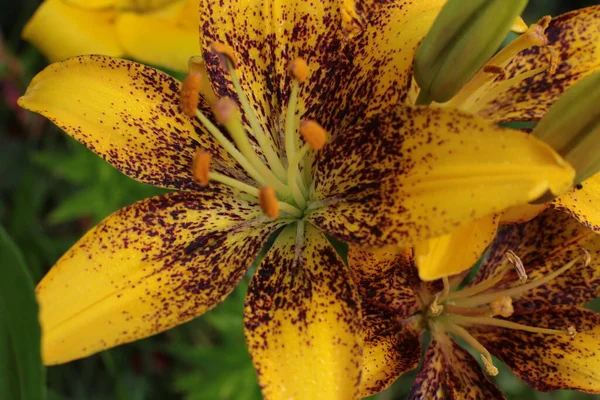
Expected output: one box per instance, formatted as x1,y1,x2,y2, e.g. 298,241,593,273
23,0,200,71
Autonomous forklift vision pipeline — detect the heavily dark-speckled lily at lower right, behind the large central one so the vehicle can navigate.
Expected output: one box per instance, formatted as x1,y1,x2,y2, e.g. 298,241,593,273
349,210,600,400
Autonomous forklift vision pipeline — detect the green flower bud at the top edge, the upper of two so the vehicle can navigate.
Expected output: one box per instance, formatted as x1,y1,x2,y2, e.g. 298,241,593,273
415,0,527,104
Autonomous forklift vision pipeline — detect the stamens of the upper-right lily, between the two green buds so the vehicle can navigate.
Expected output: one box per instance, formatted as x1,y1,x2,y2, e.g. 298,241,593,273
432,16,558,114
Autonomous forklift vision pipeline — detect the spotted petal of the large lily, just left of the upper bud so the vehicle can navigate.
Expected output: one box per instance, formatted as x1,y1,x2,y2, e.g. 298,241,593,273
324,0,446,136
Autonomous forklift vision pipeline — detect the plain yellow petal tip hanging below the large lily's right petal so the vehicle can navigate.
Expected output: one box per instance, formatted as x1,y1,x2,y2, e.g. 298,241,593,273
415,214,499,281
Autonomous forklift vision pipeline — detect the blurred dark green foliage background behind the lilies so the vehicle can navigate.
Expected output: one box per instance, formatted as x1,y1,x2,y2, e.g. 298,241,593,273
0,0,600,400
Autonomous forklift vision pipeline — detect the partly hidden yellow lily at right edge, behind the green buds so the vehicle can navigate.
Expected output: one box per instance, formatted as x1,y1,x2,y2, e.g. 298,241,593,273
409,6,600,279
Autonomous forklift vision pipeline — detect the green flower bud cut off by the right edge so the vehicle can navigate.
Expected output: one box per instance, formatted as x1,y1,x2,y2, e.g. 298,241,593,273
533,71,600,183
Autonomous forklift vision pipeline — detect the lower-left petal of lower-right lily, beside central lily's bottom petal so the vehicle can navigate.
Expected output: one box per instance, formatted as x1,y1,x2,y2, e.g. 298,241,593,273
361,301,422,398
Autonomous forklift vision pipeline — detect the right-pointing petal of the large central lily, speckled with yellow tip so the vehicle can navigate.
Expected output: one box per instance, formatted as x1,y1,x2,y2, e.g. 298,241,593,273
309,107,574,247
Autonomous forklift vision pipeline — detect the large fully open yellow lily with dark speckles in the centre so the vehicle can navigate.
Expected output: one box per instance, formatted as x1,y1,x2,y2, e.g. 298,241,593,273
20,0,574,399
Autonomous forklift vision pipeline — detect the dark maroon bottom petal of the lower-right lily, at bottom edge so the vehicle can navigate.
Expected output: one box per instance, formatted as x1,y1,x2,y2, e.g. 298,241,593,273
408,334,504,400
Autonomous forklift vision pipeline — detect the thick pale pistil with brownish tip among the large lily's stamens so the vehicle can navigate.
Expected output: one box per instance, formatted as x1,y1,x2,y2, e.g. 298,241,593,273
214,97,290,197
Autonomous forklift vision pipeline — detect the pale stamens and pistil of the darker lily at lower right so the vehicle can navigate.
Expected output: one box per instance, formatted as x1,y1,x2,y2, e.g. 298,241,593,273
425,249,590,376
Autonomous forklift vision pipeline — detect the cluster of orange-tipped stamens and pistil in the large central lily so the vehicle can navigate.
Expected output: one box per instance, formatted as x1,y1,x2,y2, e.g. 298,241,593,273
180,43,327,219
